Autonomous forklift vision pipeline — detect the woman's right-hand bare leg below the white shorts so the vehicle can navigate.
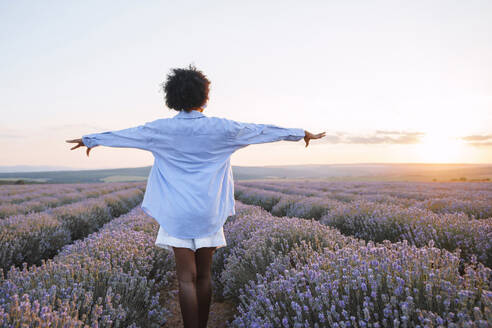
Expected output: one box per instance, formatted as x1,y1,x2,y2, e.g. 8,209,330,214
195,247,216,328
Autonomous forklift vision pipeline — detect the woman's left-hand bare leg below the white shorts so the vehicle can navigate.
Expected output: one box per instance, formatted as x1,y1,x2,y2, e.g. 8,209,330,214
173,247,199,328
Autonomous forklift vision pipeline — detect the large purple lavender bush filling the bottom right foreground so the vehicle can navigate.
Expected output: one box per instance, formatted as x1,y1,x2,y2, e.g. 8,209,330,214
231,241,492,327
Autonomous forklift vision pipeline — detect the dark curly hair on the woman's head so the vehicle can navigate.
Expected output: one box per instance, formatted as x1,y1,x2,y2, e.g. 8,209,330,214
162,64,210,112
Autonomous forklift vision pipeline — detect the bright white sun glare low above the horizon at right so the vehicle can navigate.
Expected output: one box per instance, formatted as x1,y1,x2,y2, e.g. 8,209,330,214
417,132,466,163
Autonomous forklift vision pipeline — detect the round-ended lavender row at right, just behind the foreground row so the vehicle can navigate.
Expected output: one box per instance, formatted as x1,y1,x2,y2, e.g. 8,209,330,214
320,201,492,267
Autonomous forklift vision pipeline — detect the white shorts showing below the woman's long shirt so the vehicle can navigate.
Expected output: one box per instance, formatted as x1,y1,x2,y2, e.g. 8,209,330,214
155,226,227,252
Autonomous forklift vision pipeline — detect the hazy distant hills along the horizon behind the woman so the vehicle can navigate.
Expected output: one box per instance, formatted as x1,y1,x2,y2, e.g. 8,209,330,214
0,163,492,185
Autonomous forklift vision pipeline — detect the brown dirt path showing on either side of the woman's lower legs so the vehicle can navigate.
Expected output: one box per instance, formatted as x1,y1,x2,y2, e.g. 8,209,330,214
161,278,235,328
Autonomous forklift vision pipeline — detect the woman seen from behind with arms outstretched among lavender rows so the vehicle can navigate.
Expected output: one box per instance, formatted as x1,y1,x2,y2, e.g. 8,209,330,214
67,65,325,328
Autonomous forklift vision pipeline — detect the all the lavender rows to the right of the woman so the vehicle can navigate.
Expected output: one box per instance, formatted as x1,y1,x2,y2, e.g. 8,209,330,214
228,180,492,327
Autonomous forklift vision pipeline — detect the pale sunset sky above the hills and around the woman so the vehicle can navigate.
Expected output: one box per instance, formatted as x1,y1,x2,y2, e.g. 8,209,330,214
0,0,492,169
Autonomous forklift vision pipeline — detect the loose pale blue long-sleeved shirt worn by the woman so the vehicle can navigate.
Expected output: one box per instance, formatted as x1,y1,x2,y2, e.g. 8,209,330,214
82,110,305,239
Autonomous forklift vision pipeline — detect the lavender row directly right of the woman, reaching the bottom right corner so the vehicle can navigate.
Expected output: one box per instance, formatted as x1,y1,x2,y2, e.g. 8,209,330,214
212,201,492,328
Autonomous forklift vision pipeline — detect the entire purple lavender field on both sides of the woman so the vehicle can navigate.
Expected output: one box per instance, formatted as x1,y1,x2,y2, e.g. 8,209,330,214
0,180,492,327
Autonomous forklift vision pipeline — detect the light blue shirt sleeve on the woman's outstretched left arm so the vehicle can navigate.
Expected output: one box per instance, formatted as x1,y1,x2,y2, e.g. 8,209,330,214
82,123,154,151
